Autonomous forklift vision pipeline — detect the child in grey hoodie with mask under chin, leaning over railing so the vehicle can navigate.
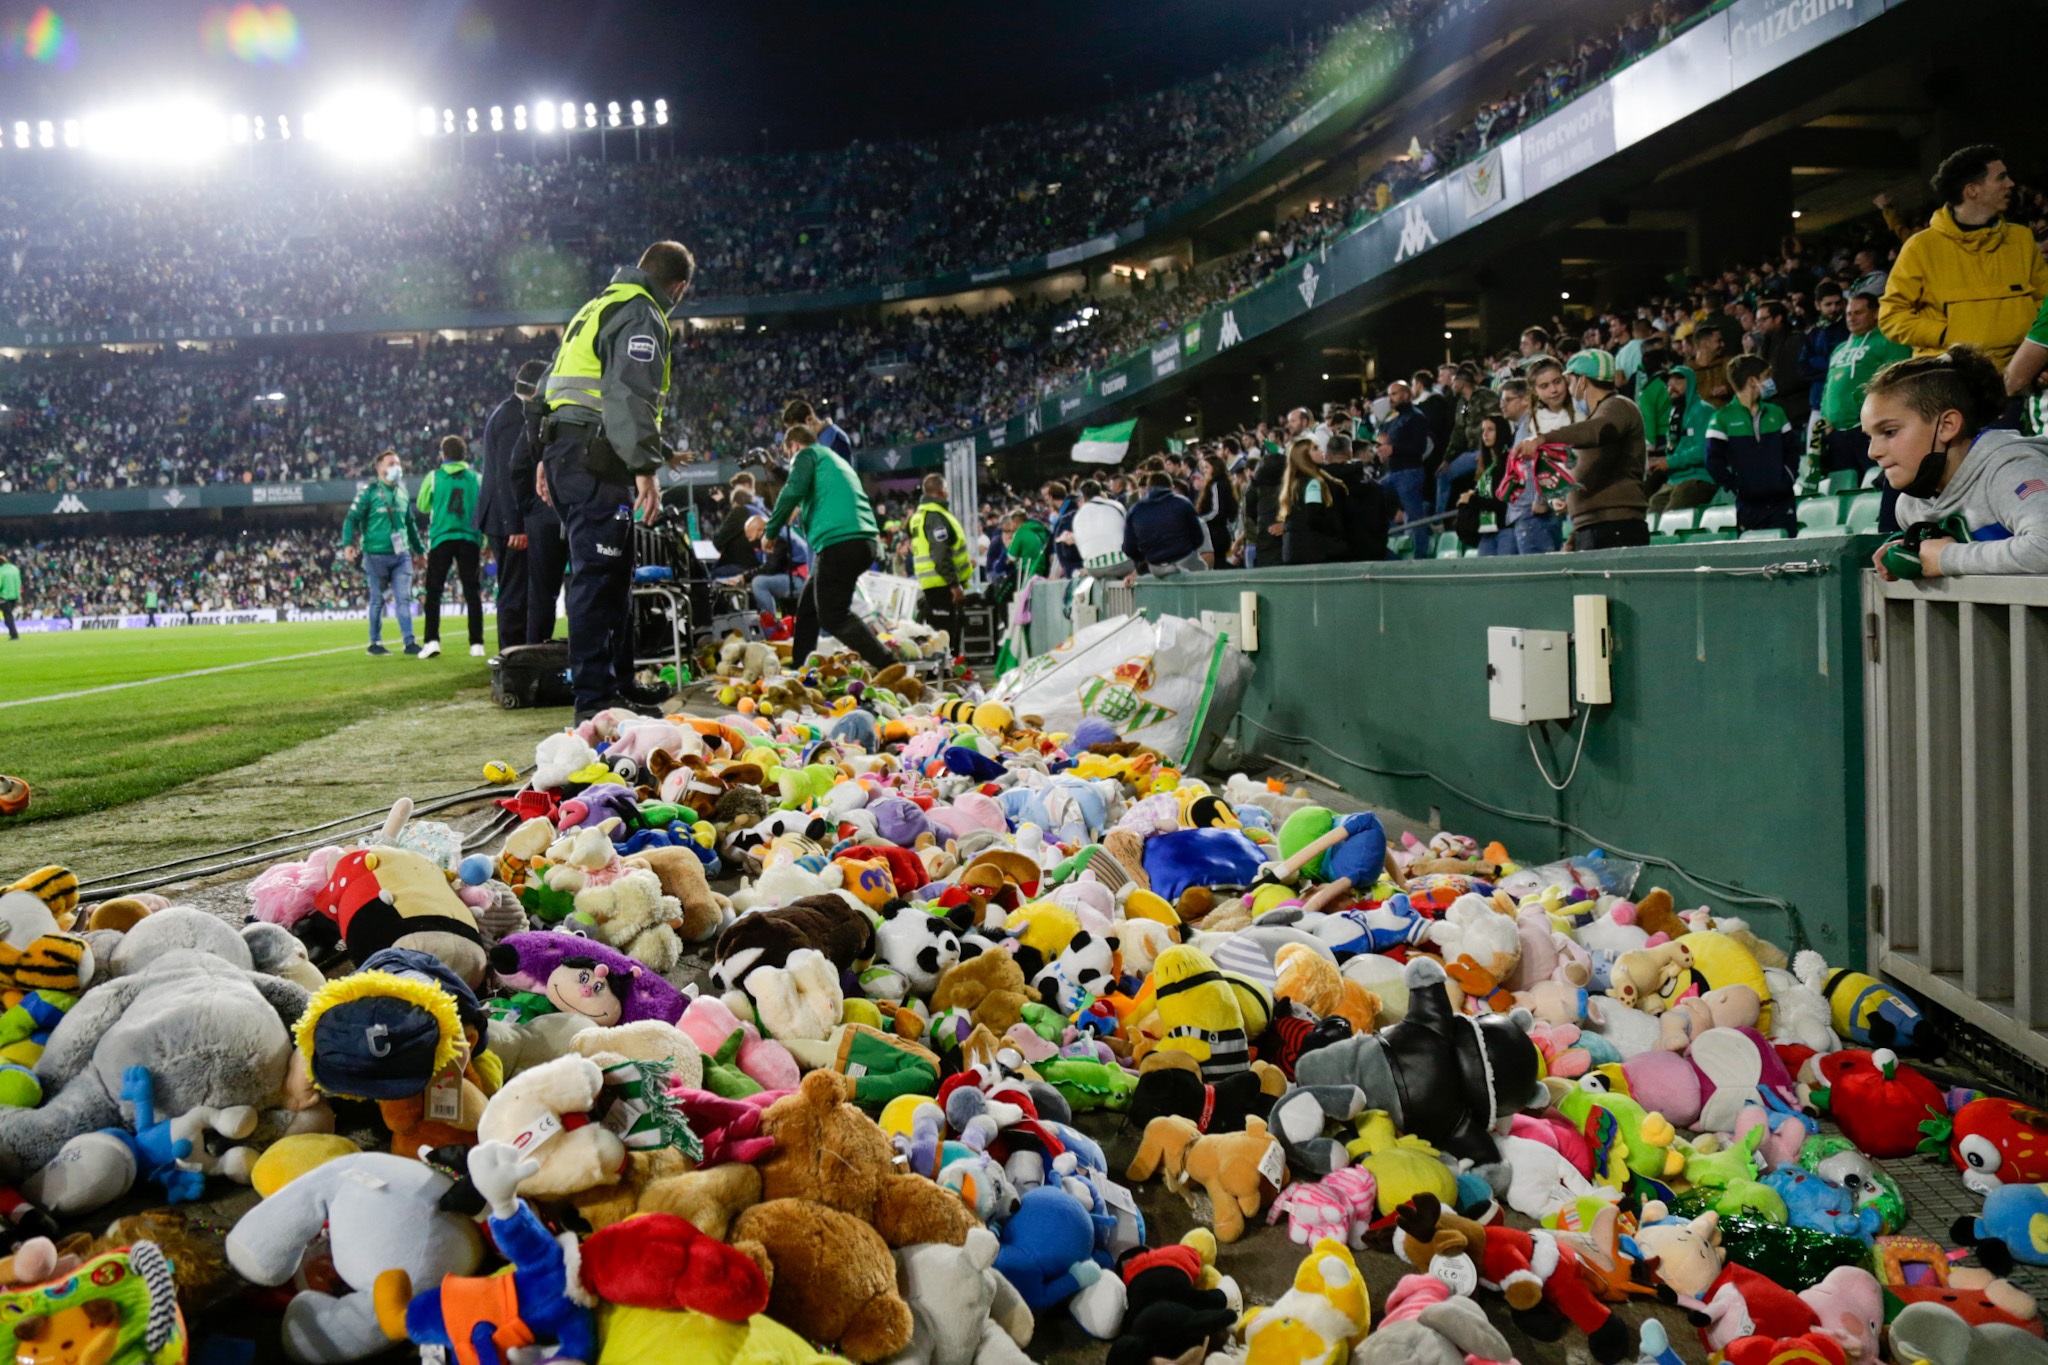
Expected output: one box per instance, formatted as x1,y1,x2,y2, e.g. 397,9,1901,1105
1864,346,2048,579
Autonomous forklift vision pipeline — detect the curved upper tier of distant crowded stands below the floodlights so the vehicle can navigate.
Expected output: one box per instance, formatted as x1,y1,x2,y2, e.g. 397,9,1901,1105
0,0,1487,332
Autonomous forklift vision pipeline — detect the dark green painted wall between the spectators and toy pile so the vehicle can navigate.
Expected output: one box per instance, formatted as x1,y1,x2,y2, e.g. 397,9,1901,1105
1032,536,1878,966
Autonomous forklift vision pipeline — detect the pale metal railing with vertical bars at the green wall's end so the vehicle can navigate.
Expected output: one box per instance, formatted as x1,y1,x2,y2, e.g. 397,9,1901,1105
1864,573,2048,1064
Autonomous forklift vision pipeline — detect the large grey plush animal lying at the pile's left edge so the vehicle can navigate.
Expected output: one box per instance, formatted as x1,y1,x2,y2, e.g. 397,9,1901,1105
0,941,307,1181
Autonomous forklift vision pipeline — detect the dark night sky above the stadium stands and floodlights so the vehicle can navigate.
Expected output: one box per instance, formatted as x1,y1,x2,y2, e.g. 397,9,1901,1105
0,0,1362,151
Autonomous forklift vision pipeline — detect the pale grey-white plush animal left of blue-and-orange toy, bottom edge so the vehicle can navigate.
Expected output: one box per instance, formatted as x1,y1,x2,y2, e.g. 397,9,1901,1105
227,1152,483,1365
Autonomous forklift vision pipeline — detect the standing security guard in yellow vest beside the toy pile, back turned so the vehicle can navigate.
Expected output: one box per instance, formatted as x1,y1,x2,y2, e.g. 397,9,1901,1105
535,241,696,720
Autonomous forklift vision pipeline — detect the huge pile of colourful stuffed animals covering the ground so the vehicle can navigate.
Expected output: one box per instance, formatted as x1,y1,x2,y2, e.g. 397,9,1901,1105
0,646,2048,1365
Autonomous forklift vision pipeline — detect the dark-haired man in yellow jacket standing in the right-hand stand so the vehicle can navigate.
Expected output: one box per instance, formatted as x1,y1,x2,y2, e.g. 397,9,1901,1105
1878,143,2048,366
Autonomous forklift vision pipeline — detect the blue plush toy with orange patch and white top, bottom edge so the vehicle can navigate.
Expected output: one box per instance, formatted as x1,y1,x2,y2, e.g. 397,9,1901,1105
406,1142,598,1365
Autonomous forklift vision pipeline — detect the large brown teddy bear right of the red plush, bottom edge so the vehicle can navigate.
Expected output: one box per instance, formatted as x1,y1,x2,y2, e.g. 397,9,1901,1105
733,1070,979,1363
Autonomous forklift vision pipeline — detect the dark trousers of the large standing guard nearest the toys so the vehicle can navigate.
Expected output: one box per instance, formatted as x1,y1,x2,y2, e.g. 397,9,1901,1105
528,426,633,714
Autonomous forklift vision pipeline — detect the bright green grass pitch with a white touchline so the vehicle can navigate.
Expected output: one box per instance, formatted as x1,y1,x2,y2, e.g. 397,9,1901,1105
0,620,503,823
